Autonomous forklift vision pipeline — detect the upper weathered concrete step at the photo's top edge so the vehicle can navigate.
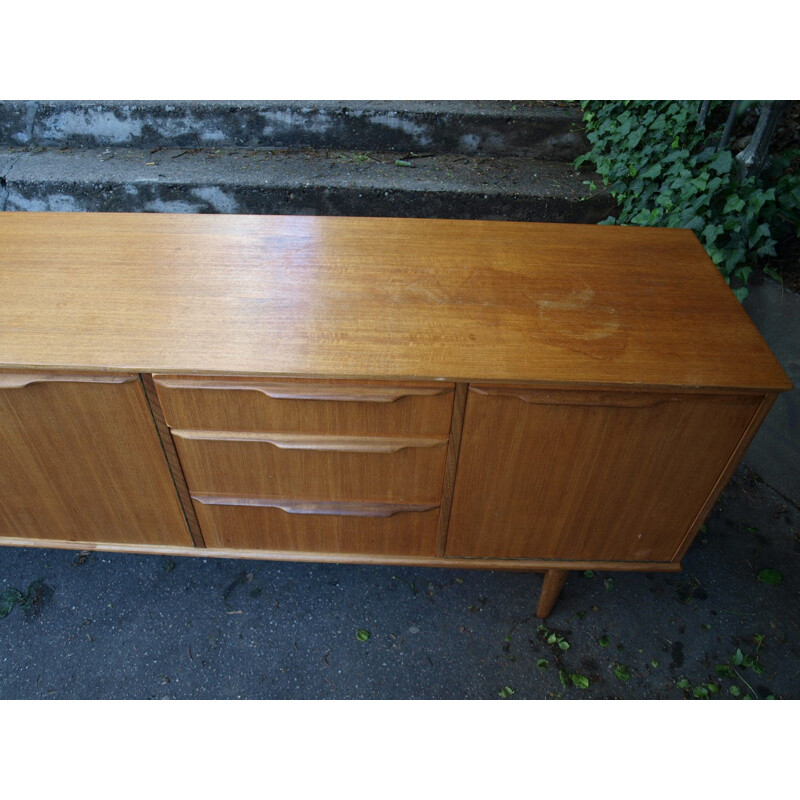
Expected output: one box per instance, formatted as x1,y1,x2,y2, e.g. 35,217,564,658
0,100,587,161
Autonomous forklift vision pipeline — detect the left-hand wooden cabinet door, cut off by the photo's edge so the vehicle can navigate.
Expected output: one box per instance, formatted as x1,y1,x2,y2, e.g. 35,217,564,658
0,372,192,546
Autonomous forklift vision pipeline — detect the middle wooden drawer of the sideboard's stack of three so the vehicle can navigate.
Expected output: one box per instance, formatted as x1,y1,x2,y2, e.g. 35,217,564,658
173,430,447,504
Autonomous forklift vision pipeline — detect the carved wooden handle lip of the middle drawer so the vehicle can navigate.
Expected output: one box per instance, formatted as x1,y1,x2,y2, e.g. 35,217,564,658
172,429,447,453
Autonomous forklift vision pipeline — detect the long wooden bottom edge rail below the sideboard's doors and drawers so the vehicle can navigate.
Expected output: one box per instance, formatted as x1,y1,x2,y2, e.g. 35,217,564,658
0,537,681,572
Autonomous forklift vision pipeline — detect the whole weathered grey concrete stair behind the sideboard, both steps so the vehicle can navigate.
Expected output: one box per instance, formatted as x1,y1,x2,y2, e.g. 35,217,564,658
0,101,613,222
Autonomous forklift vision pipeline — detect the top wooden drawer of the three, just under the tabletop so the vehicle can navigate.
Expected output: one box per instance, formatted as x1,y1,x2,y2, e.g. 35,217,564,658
155,375,454,436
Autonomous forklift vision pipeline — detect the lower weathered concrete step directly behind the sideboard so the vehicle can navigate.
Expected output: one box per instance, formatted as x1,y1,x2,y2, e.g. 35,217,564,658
0,148,611,222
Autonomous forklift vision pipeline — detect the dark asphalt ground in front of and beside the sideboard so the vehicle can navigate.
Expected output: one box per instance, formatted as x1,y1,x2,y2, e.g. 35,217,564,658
0,467,800,699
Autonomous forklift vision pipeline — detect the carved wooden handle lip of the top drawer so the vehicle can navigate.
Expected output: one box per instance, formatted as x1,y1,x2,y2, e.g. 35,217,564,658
155,378,453,403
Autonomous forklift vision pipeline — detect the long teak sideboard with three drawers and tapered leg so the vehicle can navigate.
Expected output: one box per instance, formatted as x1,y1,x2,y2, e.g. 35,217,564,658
0,212,791,617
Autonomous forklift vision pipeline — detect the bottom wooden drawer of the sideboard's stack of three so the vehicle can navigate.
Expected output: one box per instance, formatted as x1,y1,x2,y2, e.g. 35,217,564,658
193,496,439,556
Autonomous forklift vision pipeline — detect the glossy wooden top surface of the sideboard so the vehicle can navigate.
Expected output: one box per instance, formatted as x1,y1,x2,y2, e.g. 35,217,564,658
0,212,790,390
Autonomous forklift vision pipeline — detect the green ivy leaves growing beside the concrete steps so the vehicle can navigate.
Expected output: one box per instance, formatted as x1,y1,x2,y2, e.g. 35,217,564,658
575,100,800,300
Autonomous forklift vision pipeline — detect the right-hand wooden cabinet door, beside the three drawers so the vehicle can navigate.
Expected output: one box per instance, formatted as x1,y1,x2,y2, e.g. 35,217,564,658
446,386,762,562
